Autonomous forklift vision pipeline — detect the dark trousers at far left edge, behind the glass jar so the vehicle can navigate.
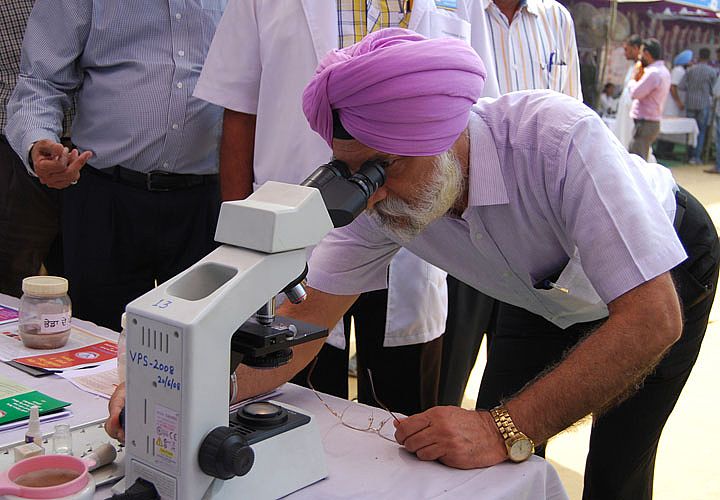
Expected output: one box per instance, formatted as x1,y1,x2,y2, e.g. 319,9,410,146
0,135,63,297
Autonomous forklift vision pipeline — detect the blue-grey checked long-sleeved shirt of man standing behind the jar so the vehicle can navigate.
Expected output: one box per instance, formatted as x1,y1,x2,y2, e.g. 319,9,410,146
5,0,226,174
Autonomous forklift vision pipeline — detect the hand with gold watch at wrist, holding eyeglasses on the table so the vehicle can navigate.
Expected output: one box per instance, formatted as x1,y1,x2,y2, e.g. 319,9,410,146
395,406,507,469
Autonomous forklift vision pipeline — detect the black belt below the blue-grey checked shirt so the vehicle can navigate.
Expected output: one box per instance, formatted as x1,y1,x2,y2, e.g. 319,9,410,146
84,165,218,191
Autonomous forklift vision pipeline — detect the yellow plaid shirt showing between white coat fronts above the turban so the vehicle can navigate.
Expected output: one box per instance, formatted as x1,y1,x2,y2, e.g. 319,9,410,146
337,0,410,48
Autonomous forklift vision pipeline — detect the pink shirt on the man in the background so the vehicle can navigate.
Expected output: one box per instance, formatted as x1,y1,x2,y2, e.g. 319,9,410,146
628,61,670,122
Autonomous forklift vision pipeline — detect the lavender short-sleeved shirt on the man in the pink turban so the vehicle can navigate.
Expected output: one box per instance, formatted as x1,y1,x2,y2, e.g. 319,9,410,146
308,91,686,327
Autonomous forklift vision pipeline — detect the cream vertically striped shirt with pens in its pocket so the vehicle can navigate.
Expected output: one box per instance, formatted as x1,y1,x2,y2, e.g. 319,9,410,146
481,0,582,99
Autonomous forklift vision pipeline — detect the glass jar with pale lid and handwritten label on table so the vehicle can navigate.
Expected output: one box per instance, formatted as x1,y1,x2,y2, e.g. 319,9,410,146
18,276,72,349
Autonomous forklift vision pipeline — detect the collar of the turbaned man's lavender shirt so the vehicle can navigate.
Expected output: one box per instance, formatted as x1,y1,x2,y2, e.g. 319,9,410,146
468,104,510,207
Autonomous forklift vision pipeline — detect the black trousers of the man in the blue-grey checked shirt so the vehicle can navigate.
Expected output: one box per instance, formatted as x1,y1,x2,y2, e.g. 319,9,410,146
62,165,220,330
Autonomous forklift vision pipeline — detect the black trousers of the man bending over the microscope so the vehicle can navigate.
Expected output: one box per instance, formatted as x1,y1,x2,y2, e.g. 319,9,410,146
477,188,720,500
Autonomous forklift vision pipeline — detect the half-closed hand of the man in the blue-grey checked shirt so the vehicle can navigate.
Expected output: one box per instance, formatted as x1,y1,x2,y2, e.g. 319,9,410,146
30,139,92,189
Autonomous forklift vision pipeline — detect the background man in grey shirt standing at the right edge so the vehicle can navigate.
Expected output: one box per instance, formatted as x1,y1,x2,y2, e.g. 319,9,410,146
678,47,717,165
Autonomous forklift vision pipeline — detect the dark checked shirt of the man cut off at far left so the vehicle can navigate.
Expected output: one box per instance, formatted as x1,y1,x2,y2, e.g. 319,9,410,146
0,0,71,133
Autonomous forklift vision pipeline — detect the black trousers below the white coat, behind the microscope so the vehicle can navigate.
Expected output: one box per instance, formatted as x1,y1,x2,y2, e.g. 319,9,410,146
292,290,442,415
